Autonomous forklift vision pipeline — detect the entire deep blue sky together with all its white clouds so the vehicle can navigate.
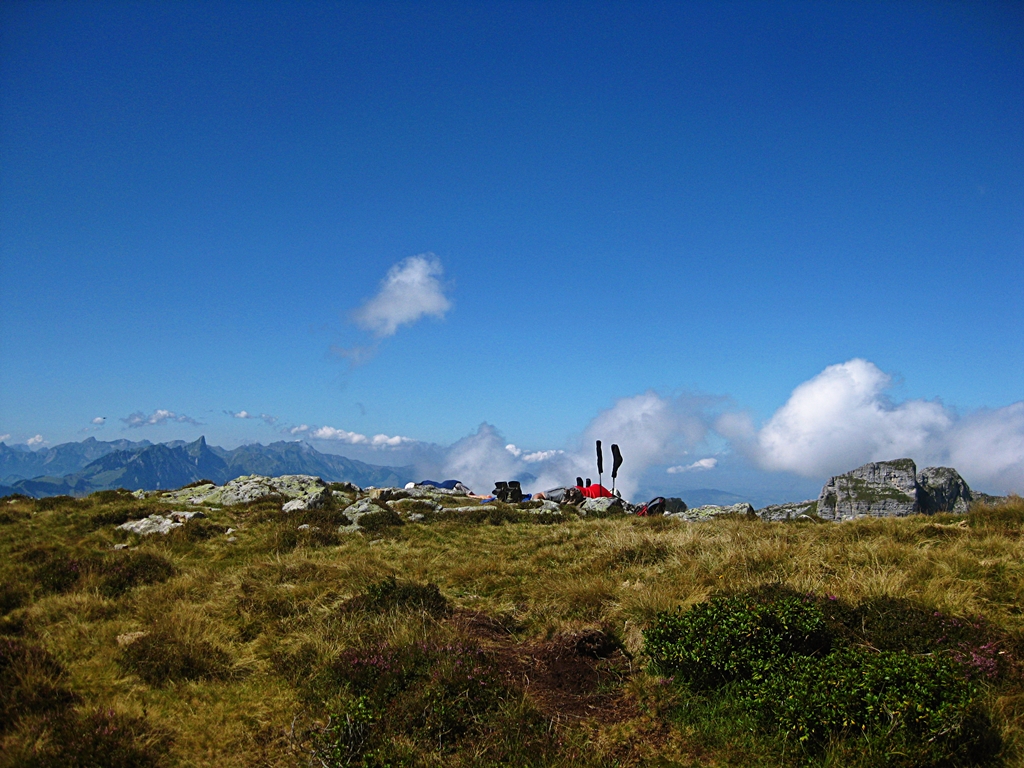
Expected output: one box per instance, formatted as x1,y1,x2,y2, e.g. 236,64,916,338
0,0,1024,498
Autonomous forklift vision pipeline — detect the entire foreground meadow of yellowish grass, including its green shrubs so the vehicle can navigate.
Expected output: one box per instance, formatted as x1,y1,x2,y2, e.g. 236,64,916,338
0,492,1024,768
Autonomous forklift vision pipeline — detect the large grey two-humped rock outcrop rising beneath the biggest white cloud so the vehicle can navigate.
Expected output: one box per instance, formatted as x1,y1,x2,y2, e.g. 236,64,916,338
817,459,972,520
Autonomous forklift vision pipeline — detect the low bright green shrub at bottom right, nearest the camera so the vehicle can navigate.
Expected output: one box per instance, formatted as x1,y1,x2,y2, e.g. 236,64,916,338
739,648,998,768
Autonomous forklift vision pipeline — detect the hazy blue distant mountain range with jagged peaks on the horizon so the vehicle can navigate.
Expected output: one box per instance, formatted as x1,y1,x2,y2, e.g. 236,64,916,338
0,437,416,498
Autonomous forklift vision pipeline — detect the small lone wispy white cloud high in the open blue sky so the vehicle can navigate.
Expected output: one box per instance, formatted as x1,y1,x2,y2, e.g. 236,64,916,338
354,253,452,337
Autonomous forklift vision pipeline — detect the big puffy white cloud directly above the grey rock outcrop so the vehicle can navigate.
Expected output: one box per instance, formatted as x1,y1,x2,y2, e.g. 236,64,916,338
715,358,1024,493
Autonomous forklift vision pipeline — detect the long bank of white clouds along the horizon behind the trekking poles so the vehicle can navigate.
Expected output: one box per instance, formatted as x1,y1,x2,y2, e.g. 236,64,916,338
354,358,1024,496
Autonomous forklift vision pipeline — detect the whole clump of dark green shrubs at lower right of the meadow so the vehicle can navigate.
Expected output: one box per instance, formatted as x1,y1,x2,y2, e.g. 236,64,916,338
644,586,999,768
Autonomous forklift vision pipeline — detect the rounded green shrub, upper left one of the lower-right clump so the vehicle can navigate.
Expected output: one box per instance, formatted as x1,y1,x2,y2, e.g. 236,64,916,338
644,595,830,690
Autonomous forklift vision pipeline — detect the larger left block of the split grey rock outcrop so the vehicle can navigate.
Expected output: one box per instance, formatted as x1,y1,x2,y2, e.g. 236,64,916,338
817,459,921,520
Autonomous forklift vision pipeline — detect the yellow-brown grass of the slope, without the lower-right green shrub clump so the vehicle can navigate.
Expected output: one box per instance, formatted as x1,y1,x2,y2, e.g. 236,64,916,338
0,494,1024,766
